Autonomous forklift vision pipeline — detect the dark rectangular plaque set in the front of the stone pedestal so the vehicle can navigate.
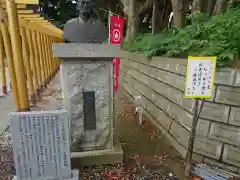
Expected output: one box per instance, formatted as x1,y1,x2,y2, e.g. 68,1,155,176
83,91,97,130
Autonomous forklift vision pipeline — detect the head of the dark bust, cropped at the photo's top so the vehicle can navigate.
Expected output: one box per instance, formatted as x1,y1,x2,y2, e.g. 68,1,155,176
77,0,93,19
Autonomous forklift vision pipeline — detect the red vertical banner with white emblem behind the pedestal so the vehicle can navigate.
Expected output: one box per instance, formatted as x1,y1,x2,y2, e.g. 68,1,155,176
109,16,124,92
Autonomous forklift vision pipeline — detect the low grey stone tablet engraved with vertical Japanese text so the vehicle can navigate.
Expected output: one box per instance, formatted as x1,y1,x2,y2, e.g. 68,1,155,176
9,110,79,180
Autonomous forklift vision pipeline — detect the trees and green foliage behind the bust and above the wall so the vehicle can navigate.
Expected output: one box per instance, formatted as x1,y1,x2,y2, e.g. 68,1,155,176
41,0,240,67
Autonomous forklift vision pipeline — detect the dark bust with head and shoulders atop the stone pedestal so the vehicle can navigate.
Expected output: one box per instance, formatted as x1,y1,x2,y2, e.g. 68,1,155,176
63,0,108,43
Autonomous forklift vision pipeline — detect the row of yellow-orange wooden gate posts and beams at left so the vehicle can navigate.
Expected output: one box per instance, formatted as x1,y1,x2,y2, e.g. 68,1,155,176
0,0,63,111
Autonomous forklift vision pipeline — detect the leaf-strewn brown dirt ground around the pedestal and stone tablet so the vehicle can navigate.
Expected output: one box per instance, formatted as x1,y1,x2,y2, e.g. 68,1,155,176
0,80,185,180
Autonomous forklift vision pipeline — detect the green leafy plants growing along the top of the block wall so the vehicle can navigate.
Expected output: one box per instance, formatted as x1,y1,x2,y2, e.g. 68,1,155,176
124,9,240,67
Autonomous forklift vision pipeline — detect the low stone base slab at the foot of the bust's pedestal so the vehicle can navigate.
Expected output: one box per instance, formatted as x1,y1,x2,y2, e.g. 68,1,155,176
71,143,123,169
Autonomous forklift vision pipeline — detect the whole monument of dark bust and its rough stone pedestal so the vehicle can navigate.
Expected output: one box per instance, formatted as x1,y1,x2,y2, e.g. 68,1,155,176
58,0,122,164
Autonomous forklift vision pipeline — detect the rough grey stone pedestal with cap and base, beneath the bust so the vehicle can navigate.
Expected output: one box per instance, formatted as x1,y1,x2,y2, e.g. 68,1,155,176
53,43,123,165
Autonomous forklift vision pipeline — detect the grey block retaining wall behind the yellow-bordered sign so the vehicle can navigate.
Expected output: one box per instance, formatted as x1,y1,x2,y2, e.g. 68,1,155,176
120,52,240,173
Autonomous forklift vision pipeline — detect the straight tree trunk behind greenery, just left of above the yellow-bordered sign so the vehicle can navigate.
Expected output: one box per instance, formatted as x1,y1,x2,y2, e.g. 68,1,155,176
171,0,185,28
